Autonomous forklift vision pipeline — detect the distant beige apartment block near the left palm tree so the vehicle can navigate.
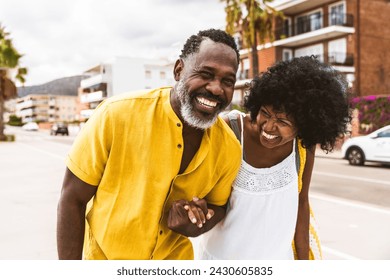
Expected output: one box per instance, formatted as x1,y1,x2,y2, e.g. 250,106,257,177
15,94,77,123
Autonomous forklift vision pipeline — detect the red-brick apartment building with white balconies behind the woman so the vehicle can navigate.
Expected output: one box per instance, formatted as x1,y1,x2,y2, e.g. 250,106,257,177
237,0,390,103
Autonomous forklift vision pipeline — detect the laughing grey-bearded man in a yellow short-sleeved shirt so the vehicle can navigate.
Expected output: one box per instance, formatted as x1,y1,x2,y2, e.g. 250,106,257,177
57,29,241,260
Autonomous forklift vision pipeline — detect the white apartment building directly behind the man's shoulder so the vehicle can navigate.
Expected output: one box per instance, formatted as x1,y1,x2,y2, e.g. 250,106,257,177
78,57,174,120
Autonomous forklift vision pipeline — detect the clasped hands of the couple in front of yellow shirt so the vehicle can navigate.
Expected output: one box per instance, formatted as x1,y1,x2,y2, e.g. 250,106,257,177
168,197,214,237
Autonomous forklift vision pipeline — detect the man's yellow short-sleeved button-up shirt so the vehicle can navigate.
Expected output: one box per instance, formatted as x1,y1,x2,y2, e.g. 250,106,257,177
66,88,241,259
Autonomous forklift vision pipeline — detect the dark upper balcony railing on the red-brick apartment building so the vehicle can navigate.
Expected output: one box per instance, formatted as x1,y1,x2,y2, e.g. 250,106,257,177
275,13,353,40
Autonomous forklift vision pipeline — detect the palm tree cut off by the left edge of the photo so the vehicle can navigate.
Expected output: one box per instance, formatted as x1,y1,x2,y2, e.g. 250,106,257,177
0,24,27,141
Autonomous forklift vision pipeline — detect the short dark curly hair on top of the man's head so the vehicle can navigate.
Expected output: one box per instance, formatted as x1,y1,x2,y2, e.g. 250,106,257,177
180,29,240,62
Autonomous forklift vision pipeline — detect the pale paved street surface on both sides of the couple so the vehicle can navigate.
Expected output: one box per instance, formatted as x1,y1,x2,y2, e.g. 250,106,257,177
0,124,390,260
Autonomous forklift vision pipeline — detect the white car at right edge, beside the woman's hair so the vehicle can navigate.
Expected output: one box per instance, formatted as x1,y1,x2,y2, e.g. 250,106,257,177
341,125,390,165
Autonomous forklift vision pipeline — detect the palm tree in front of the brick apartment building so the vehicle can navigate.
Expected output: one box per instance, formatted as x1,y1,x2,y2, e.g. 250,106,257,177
220,0,283,77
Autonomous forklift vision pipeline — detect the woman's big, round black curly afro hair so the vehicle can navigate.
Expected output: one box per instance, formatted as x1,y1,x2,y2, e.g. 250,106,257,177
244,56,351,152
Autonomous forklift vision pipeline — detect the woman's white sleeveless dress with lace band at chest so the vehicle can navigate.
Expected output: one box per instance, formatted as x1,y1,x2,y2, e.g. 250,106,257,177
198,112,298,260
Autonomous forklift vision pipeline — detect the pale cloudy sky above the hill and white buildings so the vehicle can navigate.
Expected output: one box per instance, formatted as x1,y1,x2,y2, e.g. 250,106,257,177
0,0,229,86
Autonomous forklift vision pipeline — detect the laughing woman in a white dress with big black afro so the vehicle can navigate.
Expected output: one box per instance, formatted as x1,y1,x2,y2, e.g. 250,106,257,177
194,57,350,260
